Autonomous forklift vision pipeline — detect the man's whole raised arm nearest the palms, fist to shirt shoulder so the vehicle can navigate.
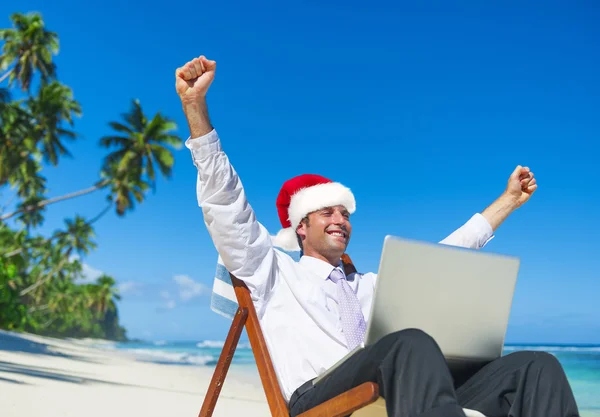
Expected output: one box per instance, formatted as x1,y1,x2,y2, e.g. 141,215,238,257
175,56,274,297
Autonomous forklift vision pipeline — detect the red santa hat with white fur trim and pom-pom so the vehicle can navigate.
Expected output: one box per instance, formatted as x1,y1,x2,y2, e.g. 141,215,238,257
273,174,356,250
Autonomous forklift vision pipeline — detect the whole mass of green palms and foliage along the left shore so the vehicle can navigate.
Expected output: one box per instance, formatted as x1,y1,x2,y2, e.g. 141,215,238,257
0,13,182,340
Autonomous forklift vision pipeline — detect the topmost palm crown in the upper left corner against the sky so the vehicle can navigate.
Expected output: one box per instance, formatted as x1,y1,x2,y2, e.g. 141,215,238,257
0,13,58,91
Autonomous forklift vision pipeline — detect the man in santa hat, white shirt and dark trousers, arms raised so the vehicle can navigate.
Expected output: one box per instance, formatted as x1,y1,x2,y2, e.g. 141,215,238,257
176,56,578,417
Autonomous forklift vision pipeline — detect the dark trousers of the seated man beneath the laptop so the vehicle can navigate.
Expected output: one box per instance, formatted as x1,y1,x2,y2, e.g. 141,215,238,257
289,329,579,417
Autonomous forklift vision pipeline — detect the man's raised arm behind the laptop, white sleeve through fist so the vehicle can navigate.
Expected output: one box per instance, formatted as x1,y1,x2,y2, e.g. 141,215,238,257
440,165,537,249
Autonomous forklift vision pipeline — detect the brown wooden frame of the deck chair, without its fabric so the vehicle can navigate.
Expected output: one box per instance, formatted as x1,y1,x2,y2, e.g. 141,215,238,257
198,255,379,417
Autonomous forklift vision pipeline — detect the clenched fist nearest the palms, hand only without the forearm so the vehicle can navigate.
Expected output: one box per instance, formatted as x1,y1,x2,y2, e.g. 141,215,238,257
175,55,217,105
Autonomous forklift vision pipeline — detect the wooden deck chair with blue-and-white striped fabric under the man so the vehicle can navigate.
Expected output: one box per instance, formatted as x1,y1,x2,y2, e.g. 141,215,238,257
198,252,485,417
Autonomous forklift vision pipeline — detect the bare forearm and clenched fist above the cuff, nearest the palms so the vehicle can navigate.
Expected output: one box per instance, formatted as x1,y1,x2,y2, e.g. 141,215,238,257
175,56,217,138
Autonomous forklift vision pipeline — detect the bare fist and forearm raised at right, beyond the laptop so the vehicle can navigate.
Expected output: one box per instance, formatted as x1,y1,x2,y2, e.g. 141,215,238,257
481,165,537,231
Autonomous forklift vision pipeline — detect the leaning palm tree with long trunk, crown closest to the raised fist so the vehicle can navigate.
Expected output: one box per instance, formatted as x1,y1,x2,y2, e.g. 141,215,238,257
0,100,183,220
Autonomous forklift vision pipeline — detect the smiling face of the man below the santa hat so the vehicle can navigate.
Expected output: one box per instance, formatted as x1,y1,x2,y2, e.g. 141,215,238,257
296,206,352,260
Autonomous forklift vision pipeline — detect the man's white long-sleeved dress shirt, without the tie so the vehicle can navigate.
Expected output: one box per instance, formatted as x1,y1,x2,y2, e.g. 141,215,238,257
186,130,493,401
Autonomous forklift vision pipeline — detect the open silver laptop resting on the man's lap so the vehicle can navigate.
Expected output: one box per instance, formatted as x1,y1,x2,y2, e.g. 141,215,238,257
313,235,520,384
